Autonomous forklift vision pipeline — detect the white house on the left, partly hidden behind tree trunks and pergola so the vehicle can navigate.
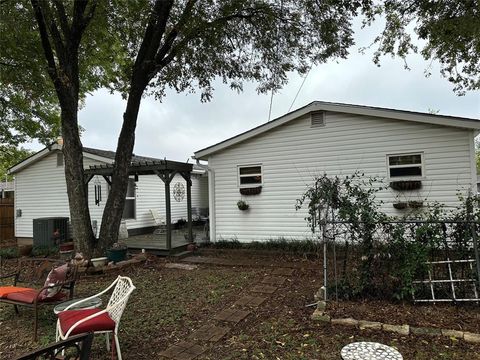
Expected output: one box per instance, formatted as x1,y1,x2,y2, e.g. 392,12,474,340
9,144,208,242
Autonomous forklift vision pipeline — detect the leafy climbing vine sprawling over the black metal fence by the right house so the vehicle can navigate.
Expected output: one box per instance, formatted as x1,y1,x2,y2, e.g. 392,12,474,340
296,172,480,300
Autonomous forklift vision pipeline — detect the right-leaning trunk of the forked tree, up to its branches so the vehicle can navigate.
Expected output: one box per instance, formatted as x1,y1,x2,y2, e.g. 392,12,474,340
98,85,144,250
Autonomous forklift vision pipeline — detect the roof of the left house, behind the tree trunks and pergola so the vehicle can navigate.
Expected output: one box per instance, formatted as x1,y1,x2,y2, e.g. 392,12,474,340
8,143,205,174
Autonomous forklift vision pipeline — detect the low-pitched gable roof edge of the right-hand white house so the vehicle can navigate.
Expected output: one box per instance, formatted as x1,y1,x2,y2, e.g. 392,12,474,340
195,101,480,160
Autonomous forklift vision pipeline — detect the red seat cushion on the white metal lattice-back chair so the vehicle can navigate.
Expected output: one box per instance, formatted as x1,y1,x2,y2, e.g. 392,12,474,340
58,309,115,335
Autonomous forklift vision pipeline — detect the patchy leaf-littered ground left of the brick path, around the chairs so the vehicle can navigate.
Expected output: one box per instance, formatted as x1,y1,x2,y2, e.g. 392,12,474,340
0,260,257,360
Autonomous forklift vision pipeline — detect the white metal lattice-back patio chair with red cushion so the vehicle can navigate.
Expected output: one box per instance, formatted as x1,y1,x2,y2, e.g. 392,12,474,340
56,276,135,360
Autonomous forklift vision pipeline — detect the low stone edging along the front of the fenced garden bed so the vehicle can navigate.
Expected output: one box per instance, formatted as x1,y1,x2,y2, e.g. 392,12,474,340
311,301,480,344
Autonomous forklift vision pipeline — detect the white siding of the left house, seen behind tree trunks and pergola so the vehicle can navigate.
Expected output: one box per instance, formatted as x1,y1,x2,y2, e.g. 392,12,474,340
15,152,208,238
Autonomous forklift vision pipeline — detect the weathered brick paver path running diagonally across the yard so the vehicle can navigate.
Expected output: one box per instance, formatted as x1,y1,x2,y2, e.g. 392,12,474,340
160,266,295,360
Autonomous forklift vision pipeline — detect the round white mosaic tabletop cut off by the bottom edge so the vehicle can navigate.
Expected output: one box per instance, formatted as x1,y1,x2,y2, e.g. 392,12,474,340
340,341,403,360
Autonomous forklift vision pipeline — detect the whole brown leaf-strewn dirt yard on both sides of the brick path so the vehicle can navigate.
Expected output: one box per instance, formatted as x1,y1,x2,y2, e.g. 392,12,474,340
0,250,480,360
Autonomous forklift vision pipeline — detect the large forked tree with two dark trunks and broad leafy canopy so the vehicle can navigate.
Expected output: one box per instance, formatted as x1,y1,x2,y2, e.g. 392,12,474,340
0,0,478,252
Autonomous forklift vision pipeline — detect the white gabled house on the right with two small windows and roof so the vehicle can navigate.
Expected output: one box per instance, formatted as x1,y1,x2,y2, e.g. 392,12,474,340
195,102,480,241
